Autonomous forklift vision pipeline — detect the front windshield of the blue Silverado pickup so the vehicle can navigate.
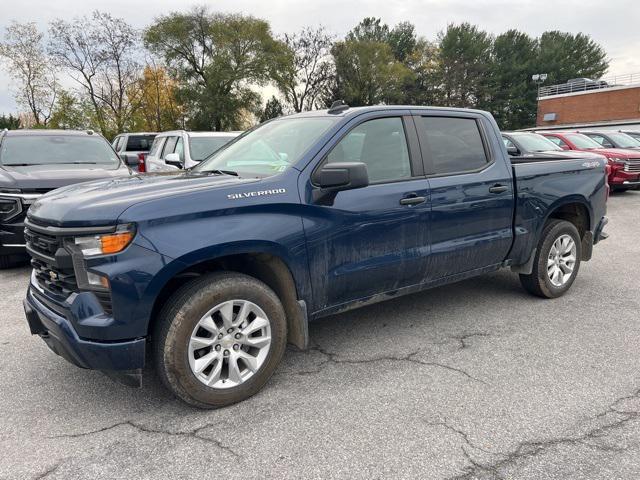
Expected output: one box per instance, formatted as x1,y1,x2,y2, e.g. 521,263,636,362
194,117,338,177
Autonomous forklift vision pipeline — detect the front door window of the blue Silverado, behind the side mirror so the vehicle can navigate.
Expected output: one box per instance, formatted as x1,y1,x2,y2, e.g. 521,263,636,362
327,117,411,183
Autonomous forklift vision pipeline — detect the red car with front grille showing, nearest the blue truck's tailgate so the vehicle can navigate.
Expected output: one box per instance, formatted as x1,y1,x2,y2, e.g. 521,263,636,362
537,131,640,192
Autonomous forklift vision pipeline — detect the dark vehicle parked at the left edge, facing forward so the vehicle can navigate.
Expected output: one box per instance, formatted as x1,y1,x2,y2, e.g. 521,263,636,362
0,130,131,268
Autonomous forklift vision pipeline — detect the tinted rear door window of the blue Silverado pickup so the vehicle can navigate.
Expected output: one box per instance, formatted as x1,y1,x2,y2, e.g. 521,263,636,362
418,117,489,175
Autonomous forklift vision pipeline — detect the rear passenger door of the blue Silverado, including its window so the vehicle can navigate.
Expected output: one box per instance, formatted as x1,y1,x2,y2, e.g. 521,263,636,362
414,112,514,280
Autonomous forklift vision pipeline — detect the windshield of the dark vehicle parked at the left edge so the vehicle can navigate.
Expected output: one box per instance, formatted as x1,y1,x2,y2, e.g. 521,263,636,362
0,135,120,169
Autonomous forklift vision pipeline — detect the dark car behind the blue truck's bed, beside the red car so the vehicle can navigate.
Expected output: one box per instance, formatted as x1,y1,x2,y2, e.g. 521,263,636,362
502,132,605,160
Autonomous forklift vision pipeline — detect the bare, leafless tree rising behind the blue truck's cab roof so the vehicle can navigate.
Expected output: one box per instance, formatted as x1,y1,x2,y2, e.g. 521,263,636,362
276,27,333,112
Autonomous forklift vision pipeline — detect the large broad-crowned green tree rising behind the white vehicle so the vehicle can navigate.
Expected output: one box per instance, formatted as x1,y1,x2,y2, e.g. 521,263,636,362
144,7,290,130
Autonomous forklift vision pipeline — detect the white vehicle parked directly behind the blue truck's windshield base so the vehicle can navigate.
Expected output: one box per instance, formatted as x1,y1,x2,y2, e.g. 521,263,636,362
146,130,241,172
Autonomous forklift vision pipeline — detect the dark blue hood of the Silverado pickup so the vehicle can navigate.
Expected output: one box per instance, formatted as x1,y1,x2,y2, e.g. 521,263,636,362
28,172,259,227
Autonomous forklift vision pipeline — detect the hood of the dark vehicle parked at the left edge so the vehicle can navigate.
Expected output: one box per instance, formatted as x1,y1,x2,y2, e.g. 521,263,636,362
0,161,132,192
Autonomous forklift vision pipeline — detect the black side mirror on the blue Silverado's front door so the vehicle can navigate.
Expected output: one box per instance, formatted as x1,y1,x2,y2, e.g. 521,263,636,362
313,162,369,203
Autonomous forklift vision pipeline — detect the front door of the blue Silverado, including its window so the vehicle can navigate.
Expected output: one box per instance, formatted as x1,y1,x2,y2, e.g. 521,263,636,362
301,111,429,311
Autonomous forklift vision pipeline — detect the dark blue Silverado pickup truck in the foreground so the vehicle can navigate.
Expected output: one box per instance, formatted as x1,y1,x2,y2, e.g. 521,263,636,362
24,104,608,407
